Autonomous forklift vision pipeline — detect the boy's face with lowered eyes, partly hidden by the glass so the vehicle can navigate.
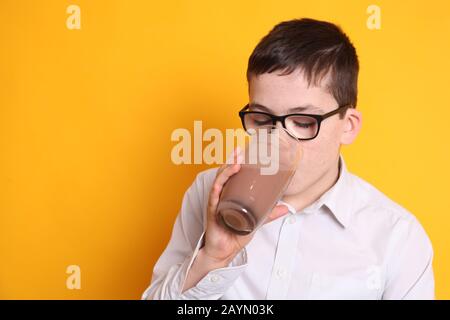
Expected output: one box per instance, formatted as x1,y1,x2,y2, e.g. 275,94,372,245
249,70,358,196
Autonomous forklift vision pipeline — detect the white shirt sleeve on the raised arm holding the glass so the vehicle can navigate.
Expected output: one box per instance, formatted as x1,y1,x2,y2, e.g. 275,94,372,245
142,170,247,300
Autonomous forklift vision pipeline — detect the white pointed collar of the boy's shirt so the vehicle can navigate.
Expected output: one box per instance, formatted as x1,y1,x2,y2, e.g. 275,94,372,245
279,155,352,228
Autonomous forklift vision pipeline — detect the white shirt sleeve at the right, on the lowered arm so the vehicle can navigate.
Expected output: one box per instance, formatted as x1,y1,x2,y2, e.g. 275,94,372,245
383,217,435,300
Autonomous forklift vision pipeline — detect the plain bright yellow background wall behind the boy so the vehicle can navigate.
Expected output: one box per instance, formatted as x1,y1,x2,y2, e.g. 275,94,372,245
0,0,450,299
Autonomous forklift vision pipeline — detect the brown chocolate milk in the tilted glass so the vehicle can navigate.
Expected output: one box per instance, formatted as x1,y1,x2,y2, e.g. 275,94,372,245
217,165,295,235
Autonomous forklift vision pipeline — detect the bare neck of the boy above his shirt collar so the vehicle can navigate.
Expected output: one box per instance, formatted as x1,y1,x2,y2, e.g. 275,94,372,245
282,159,340,212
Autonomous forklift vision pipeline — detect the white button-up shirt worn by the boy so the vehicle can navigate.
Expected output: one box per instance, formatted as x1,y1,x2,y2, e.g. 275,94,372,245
142,156,434,299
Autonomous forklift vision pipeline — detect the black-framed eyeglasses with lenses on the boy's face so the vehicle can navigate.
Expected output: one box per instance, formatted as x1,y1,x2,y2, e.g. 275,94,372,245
239,104,351,140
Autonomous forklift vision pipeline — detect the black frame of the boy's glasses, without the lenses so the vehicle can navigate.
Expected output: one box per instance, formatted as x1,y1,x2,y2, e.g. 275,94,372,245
239,104,352,141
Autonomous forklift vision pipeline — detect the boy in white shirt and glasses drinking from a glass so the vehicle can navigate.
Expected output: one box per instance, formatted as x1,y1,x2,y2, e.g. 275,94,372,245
143,19,434,299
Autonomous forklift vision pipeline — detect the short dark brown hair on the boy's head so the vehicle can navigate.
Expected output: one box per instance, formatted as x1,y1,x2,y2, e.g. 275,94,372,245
247,18,359,114
